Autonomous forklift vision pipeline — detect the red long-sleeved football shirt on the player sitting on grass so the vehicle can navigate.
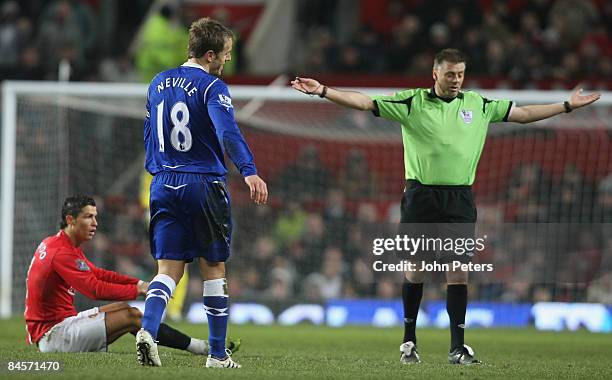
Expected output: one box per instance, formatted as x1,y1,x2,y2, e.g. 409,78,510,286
24,231,138,343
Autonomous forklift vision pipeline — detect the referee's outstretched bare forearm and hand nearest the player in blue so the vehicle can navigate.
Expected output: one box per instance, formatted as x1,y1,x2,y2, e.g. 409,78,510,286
291,77,375,111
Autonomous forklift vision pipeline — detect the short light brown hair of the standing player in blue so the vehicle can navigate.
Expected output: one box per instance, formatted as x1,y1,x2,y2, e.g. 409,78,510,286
188,17,234,58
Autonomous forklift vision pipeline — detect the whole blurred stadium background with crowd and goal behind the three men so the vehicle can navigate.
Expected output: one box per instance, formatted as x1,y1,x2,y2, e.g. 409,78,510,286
0,0,612,331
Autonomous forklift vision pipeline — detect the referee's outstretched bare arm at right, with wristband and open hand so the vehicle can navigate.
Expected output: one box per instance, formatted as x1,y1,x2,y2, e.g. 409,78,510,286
508,88,601,123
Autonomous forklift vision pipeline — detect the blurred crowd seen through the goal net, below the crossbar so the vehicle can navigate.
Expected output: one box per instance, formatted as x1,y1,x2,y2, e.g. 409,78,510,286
83,142,612,312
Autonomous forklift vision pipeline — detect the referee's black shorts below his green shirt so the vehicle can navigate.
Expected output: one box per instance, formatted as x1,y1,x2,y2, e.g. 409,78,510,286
400,179,477,263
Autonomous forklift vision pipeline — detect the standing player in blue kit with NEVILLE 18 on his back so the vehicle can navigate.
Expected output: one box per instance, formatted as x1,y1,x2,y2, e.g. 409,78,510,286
136,18,268,368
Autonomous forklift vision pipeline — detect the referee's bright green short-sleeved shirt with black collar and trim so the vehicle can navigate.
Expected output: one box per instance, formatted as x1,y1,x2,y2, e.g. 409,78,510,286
372,88,512,185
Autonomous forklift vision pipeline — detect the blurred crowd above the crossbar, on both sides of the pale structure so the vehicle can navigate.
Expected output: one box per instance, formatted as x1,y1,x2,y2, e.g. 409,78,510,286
0,0,612,86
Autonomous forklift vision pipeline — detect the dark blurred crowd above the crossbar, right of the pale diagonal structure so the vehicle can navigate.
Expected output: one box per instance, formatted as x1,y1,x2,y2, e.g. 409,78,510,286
303,0,612,86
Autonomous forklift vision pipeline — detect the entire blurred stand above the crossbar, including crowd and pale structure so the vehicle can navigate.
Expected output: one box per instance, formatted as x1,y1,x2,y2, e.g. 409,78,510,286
0,0,612,84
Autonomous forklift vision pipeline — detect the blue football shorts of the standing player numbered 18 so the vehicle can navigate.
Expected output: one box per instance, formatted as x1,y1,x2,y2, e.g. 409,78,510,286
149,172,232,262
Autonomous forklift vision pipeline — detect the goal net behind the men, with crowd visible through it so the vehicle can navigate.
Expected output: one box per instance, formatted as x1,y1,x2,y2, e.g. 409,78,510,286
0,82,612,317
